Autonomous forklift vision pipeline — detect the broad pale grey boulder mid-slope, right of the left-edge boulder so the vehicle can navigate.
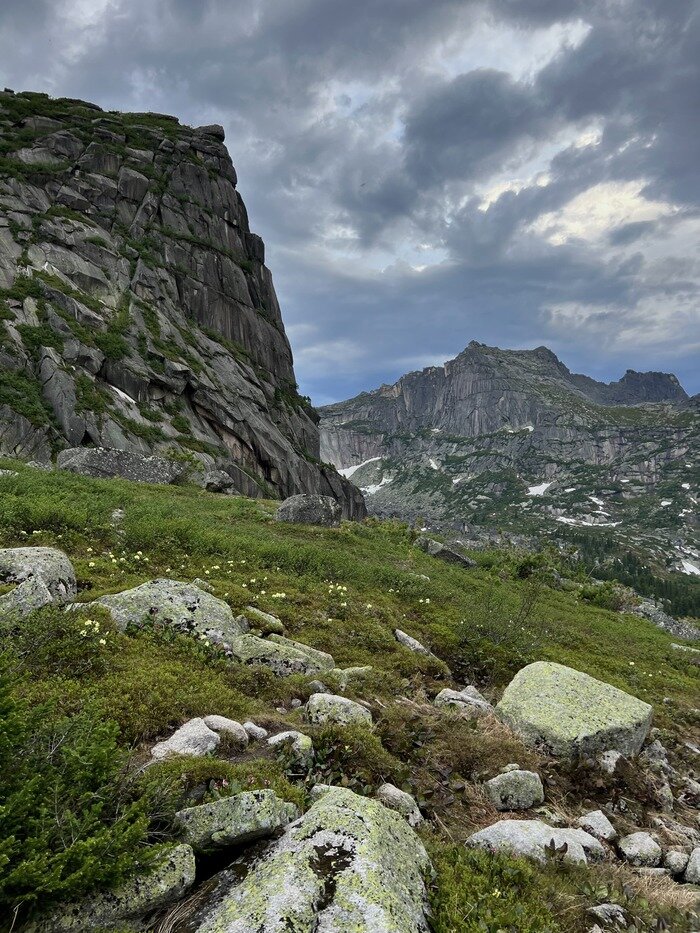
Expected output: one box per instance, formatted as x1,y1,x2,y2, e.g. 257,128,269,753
89,579,246,645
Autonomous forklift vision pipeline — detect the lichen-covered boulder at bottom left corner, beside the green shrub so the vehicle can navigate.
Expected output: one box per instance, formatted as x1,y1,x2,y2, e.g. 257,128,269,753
24,844,195,933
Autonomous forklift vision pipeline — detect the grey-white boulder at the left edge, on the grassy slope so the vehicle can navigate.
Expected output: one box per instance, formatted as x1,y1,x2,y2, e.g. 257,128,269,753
0,547,78,608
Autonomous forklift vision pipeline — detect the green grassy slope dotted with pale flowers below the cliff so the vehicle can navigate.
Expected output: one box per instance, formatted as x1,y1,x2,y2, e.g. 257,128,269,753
0,462,698,931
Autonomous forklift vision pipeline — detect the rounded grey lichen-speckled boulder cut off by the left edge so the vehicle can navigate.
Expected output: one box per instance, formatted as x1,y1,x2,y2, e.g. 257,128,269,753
0,547,78,612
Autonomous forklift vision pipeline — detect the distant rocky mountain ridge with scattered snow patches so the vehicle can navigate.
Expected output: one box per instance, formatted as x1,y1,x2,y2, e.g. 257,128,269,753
320,342,700,574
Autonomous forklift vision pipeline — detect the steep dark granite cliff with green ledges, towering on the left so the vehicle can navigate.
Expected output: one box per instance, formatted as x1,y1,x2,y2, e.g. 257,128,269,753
0,92,364,517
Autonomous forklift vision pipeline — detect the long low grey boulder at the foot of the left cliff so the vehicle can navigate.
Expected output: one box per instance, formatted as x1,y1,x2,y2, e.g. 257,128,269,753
56,447,187,484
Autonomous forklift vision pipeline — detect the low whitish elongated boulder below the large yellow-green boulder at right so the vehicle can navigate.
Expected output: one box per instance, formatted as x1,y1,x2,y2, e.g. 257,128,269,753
466,820,605,865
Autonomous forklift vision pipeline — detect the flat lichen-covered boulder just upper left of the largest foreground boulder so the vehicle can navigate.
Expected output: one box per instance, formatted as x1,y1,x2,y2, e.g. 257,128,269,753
175,790,299,852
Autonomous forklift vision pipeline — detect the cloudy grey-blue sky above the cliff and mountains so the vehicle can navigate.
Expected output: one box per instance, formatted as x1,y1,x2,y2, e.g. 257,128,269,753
0,0,700,405
